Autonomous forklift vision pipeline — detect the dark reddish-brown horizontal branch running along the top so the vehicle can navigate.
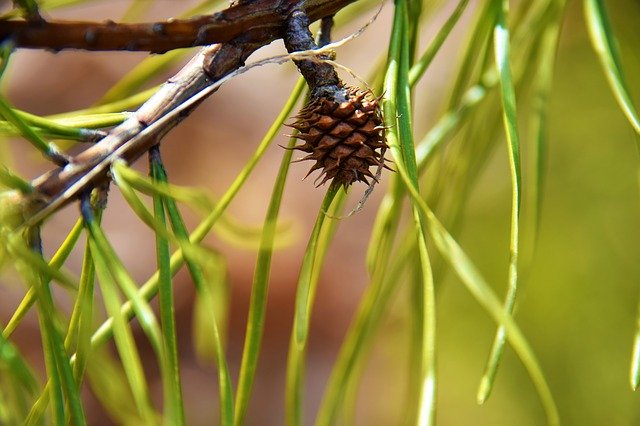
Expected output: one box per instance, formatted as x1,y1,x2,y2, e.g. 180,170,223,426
0,0,355,53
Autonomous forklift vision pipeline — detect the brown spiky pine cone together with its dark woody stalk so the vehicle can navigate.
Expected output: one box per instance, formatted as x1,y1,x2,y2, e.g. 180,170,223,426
284,11,387,187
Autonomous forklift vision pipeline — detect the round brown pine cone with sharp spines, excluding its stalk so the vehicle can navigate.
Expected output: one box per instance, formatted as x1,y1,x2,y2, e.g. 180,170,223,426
290,86,387,187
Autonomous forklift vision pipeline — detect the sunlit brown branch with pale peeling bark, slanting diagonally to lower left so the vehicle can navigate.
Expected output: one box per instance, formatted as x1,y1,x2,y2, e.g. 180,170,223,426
17,0,355,226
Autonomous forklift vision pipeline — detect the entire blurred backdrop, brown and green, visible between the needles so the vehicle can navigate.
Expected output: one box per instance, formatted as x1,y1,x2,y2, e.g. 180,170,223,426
0,0,640,425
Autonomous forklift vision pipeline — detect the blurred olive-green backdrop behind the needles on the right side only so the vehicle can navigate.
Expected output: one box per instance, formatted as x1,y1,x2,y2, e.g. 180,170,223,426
410,1,640,425
